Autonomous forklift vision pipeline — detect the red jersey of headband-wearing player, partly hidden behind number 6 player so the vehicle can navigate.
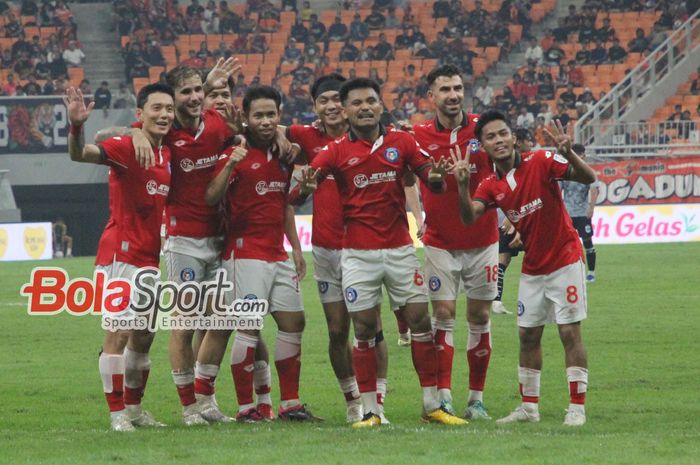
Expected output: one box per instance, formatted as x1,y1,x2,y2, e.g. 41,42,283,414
287,124,345,249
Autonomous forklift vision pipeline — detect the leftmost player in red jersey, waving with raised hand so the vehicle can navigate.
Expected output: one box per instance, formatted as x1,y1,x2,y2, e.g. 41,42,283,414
64,84,174,431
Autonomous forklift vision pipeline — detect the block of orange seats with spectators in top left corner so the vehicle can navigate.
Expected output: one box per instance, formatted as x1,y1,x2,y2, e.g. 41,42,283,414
0,0,85,96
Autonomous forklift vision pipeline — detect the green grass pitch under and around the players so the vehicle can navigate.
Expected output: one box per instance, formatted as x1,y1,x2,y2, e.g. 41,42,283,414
0,243,700,465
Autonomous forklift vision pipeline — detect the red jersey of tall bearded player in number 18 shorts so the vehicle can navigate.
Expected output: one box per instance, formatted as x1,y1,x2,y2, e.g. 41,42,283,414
413,114,498,250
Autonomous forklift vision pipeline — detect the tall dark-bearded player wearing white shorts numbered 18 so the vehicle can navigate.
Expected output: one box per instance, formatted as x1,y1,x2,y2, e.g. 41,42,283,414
413,65,498,419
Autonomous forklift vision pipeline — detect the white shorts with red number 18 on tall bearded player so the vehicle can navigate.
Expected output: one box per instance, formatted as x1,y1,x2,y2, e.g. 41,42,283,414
425,243,498,301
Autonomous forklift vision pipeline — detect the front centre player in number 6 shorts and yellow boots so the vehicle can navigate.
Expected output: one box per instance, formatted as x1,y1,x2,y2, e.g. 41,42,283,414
299,78,466,428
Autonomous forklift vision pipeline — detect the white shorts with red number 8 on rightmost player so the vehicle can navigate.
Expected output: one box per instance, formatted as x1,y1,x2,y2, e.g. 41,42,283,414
518,260,587,328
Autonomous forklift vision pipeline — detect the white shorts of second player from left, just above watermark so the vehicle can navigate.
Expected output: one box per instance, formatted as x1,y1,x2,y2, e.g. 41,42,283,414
163,236,222,283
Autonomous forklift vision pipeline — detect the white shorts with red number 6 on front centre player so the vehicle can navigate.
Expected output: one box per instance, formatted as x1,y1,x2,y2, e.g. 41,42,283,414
341,245,428,312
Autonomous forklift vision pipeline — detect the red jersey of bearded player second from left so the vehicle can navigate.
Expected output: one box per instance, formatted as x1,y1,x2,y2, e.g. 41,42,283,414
165,109,233,237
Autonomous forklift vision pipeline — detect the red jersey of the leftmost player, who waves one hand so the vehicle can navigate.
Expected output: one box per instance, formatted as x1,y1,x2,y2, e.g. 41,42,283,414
95,136,170,267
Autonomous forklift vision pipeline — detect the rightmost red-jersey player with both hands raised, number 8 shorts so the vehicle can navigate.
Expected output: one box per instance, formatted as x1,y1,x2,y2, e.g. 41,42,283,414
453,111,595,426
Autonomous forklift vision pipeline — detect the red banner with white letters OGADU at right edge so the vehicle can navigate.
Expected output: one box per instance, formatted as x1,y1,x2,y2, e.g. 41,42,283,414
591,156,700,205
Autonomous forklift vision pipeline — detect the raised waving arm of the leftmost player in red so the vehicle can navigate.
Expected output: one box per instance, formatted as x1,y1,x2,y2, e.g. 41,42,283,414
63,87,102,163
